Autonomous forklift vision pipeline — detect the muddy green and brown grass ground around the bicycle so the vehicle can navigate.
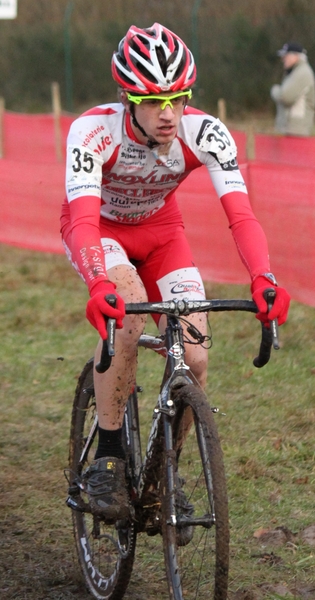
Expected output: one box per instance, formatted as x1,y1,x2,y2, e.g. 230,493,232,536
0,246,315,600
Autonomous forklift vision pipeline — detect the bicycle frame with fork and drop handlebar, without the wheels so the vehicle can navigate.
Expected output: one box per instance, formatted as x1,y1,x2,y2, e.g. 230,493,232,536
69,296,279,506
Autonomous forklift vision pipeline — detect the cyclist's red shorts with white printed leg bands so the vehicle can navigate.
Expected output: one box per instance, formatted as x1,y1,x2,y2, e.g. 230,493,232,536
62,198,205,302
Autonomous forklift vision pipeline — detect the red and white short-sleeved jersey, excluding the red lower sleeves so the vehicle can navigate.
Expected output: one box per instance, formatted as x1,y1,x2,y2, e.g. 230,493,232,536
66,104,246,224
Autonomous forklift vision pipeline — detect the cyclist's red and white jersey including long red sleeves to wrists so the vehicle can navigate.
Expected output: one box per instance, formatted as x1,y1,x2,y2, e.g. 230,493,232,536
61,103,270,292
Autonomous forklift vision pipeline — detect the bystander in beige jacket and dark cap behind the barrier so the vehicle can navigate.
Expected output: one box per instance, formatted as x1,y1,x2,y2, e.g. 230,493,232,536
270,42,315,136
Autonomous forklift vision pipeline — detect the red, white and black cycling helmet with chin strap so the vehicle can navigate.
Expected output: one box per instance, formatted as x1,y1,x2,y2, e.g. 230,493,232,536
112,23,196,148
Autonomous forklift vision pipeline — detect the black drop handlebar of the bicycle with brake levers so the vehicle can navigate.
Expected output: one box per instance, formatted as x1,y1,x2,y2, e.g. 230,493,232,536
95,288,280,373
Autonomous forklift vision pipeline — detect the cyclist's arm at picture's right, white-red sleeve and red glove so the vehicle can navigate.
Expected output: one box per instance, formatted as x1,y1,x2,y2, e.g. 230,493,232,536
188,118,290,325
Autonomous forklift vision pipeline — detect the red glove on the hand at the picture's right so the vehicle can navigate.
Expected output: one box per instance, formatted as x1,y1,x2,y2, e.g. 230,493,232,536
251,275,290,325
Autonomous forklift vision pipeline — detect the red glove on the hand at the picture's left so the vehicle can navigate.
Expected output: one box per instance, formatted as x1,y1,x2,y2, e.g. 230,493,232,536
86,281,125,340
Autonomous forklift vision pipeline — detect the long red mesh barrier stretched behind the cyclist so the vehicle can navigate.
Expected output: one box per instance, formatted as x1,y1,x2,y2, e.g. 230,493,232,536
0,113,315,306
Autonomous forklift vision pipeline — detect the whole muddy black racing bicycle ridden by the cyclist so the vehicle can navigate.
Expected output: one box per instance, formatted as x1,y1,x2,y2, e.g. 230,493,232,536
67,289,279,600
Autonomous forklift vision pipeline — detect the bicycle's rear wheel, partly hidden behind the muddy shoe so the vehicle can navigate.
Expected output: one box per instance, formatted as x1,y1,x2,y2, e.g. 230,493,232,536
69,359,136,600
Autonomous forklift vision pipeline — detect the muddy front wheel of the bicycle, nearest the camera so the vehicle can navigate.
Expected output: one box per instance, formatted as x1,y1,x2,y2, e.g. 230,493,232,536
161,385,229,600
